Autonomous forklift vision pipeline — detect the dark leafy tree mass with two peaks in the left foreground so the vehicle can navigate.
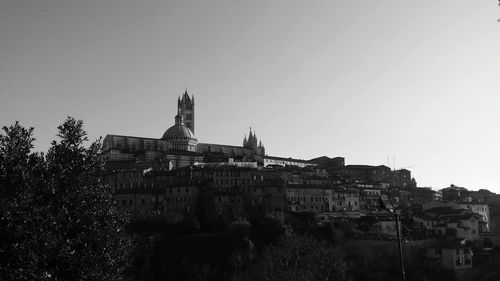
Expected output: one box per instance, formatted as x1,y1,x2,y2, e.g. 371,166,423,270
0,117,130,280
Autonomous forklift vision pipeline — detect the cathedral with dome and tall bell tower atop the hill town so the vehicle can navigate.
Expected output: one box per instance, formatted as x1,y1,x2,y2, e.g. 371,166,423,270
101,90,265,170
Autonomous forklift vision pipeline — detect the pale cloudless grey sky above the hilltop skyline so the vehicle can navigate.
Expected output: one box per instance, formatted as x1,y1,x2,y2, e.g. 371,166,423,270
0,0,500,193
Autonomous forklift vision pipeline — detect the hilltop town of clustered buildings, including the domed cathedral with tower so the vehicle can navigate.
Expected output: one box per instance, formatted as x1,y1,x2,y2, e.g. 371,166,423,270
101,91,492,274
